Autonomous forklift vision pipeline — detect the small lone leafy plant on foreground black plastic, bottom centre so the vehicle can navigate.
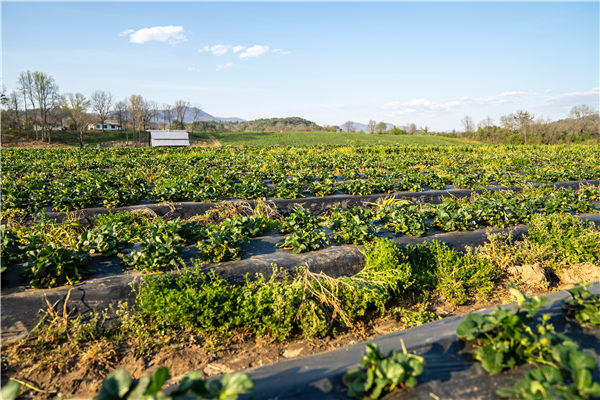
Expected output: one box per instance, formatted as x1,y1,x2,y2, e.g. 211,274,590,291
344,343,425,399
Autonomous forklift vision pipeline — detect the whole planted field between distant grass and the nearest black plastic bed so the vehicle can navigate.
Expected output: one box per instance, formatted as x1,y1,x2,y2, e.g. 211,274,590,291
2,145,600,398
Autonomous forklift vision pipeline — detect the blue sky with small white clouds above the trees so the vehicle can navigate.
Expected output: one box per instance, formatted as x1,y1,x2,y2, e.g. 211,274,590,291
2,1,600,130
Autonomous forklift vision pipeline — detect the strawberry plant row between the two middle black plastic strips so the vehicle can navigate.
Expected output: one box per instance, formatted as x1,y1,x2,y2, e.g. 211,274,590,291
1,186,600,287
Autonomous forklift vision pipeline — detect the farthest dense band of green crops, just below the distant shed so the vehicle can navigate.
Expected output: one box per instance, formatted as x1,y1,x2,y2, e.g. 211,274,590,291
1,146,600,218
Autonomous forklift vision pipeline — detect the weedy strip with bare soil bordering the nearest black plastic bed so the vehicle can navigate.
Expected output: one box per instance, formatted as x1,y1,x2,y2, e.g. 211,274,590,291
2,214,600,398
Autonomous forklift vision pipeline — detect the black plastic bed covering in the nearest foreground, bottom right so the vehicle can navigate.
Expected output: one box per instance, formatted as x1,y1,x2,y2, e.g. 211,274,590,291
236,282,600,400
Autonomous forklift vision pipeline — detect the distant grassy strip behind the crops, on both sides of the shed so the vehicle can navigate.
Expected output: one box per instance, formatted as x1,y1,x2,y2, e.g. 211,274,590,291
2,132,468,147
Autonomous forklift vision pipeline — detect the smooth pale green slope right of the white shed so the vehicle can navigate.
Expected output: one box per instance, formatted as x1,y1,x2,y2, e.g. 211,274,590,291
206,132,466,146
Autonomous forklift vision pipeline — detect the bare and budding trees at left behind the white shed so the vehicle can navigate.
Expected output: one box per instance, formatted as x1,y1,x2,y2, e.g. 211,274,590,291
0,70,201,147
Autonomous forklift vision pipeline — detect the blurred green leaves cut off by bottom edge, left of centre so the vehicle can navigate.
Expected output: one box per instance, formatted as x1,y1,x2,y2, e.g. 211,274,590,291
94,367,254,400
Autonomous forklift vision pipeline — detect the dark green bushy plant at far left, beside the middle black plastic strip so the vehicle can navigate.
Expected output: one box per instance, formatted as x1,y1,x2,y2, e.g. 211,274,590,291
21,243,93,288
